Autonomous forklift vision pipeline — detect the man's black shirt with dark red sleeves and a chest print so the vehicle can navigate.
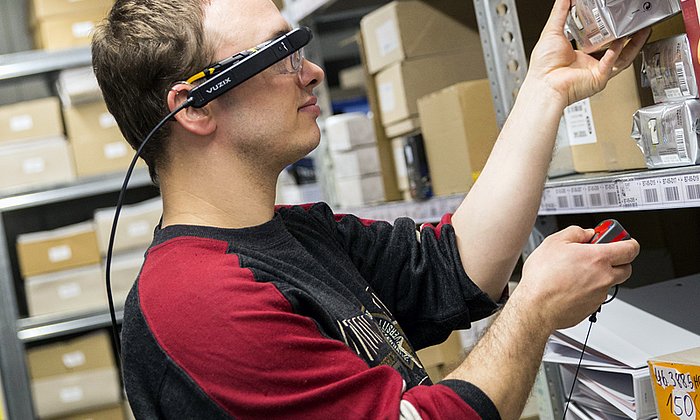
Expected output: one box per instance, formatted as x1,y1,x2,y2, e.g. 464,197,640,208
122,203,499,419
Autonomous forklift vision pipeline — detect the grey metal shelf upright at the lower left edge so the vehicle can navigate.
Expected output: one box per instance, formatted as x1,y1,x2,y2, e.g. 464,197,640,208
0,217,34,419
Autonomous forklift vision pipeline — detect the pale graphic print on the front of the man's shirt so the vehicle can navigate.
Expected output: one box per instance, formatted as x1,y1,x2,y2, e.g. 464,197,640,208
337,288,423,378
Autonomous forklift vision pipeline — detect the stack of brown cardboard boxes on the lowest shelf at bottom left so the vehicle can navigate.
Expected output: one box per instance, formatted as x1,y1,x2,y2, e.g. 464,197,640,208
27,331,123,419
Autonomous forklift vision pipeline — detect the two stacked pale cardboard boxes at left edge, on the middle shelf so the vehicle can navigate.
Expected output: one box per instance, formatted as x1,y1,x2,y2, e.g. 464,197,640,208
0,98,75,193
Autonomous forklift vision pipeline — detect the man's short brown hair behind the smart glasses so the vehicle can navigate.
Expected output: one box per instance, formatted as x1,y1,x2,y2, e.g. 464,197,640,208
92,0,214,183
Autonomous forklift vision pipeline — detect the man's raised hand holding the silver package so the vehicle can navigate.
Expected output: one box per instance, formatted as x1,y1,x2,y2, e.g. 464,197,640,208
528,0,651,105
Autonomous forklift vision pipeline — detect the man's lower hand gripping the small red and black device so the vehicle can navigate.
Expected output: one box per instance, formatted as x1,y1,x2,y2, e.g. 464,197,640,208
513,226,639,330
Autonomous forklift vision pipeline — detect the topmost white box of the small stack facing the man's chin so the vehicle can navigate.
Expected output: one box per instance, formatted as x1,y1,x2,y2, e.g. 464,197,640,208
326,112,377,151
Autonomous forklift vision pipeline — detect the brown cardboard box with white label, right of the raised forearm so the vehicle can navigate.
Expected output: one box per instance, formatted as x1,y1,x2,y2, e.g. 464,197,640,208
549,67,646,177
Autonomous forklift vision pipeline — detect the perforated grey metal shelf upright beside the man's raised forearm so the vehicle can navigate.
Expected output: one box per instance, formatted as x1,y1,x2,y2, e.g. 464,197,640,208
474,0,527,127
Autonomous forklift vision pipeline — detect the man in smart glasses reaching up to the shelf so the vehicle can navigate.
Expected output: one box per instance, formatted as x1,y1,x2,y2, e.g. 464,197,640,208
93,0,648,419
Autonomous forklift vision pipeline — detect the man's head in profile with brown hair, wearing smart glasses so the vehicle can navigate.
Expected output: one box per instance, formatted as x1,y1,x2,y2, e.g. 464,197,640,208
92,0,323,184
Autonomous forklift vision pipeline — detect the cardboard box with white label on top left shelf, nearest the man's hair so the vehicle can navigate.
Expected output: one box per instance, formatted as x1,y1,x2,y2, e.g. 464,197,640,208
34,9,105,50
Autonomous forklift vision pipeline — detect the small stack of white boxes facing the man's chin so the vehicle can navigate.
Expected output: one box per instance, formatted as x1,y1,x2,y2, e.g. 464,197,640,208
326,113,384,207
